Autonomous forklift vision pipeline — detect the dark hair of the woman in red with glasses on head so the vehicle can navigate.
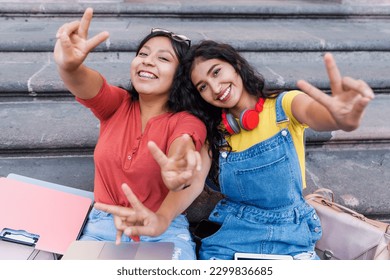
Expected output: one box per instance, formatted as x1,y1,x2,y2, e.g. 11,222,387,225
128,31,196,113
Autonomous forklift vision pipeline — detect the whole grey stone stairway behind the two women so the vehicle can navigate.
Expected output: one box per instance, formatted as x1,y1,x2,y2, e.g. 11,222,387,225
0,0,390,220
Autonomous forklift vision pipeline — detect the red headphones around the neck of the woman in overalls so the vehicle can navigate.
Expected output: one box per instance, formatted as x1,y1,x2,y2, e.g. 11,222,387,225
222,98,265,135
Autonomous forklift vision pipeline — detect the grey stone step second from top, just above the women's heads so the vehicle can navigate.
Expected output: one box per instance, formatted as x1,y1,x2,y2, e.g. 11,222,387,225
0,14,390,52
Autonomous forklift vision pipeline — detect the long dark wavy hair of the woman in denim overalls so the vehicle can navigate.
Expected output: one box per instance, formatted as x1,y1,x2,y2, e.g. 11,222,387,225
173,40,277,184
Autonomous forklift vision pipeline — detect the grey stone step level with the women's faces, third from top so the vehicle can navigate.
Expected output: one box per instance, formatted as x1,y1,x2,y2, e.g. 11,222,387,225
0,52,390,94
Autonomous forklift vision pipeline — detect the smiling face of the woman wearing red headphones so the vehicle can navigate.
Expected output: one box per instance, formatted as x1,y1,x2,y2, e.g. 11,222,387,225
191,58,246,109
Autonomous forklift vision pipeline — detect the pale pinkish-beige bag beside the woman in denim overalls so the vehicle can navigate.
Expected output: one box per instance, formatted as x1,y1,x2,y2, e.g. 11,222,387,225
305,188,390,260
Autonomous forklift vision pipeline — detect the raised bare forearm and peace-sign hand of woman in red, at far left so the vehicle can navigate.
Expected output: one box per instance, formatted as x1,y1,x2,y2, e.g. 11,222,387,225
54,8,109,99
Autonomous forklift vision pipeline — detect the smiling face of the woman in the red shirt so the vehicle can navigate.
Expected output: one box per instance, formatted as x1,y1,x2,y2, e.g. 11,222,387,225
130,36,179,98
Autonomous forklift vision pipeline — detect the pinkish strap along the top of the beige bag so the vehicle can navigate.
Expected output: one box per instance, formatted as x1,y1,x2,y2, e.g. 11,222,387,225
305,188,390,234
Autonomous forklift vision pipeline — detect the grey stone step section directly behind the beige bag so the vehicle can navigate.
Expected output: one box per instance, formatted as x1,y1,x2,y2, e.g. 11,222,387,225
304,144,390,220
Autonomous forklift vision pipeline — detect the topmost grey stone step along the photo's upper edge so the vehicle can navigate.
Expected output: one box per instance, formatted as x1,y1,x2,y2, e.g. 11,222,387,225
0,0,390,18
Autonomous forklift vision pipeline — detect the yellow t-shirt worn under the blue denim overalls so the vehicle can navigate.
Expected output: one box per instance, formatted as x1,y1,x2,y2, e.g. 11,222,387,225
226,90,307,188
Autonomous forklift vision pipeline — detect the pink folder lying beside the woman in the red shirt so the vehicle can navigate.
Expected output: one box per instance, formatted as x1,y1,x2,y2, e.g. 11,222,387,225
0,178,92,255
